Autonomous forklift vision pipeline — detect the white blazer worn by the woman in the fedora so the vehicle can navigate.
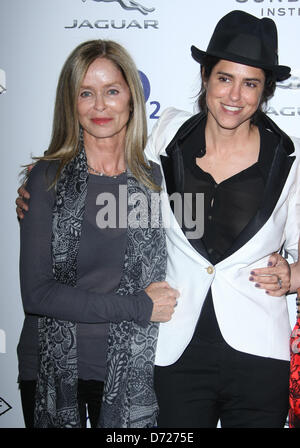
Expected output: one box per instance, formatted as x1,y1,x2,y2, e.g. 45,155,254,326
146,108,300,366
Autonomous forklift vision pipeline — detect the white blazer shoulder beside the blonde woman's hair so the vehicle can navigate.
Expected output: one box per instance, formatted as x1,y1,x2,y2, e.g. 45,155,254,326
146,107,193,160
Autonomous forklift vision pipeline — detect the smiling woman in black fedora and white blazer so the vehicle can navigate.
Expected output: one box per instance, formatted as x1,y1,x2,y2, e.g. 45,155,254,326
146,11,300,428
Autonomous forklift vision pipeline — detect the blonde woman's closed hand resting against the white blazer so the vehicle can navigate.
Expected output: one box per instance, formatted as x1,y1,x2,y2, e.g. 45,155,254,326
145,282,179,322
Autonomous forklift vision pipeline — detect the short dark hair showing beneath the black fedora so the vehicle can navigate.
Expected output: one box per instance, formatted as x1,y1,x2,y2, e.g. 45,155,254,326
198,55,276,123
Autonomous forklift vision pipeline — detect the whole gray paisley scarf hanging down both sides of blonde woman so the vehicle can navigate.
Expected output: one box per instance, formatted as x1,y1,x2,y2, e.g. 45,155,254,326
35,146,167,428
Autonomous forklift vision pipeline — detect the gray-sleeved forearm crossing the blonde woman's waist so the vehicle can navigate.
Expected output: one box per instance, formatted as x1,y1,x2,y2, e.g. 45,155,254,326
21,277,153,325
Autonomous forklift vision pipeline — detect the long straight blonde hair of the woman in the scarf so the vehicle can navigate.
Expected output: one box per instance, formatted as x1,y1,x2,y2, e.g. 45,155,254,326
36,40,159,190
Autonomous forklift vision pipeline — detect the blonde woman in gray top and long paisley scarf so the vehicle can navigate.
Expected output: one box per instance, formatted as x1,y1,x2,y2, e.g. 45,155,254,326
18,40,178,428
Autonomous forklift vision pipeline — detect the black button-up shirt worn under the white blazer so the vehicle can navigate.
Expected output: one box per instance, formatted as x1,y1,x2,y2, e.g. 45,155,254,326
181,120,279,341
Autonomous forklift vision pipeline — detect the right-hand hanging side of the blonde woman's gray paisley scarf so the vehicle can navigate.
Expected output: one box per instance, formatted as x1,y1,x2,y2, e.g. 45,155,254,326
100,176,167,428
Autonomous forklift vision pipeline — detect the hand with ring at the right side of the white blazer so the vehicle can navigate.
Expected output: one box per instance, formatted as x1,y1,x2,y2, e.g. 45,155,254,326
249,253,291,297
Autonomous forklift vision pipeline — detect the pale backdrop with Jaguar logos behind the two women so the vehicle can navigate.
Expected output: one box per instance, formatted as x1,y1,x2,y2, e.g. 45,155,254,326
0,0,300,428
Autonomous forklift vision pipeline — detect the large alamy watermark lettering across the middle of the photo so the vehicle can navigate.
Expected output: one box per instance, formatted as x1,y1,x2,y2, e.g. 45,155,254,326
96,185,204,239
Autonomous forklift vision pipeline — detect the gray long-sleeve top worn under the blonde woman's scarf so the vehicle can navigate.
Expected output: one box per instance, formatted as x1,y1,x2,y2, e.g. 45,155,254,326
18,162,153,381
